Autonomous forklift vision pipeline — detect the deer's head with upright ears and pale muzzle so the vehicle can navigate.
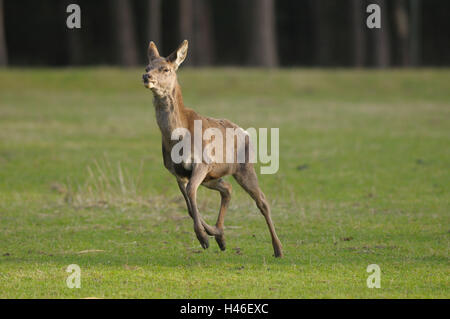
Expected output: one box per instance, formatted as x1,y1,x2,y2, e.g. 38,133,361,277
142,40,188,96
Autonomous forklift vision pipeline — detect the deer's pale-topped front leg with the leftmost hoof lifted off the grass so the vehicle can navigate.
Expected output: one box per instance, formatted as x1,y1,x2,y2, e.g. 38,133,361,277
186,164,209,249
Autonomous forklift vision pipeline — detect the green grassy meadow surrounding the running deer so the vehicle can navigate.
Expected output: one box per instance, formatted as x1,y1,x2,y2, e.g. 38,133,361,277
0,69,450,298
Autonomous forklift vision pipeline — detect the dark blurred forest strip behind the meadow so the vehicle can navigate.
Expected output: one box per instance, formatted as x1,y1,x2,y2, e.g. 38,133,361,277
0,0,450,68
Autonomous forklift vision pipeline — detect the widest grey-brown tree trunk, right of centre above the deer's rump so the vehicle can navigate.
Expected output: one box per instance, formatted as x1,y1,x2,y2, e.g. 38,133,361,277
248,0,278,67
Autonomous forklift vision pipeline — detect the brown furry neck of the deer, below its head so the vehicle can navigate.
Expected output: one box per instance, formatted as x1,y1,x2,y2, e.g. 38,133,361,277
153,83,186,143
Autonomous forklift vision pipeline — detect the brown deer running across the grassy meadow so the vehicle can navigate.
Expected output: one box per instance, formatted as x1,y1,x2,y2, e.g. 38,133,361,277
142,40,283,257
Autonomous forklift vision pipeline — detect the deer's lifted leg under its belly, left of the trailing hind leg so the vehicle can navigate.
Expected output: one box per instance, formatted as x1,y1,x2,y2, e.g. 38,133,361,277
202,178,231,250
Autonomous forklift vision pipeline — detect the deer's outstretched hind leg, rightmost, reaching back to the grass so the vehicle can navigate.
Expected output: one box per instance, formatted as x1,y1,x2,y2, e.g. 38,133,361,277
233,163,283,257
